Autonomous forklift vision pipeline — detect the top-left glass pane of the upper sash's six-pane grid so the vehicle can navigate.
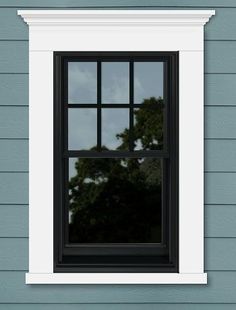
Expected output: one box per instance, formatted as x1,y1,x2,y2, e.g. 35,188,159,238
68,62,97,103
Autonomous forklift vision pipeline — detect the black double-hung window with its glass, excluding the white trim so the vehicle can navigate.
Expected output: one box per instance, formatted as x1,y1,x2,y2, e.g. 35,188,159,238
54,52,178,272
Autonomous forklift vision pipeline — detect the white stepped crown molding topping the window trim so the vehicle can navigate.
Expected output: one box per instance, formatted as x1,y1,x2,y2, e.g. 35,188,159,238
17,10,215,26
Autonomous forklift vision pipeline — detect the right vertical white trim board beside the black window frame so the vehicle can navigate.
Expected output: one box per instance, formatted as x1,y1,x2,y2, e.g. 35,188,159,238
179,51,204,273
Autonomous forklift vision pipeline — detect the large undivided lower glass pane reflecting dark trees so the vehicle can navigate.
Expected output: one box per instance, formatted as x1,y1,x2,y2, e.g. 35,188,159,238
69,158,162,243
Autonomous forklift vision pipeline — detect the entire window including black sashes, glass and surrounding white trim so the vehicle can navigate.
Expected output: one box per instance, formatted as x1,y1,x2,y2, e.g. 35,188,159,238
18,10,215,284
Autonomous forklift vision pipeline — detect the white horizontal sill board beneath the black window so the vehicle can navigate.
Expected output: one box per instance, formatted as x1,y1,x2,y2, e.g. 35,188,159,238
25,273,207,284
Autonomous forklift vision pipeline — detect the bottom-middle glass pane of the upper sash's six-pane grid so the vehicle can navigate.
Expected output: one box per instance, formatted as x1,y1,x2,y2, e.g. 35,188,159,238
102,108,129,150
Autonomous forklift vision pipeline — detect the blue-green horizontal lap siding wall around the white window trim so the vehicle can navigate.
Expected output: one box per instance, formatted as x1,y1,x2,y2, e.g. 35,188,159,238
0,0,236,310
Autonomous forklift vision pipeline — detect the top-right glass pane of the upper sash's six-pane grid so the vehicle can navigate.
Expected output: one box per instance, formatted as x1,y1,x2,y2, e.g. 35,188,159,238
134,62,163,103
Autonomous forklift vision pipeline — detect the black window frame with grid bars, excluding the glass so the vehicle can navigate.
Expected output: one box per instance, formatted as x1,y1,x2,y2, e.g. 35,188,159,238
53,52,179,272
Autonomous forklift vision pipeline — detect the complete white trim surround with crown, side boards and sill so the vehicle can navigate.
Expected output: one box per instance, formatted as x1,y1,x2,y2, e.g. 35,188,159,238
18,10,215,284
